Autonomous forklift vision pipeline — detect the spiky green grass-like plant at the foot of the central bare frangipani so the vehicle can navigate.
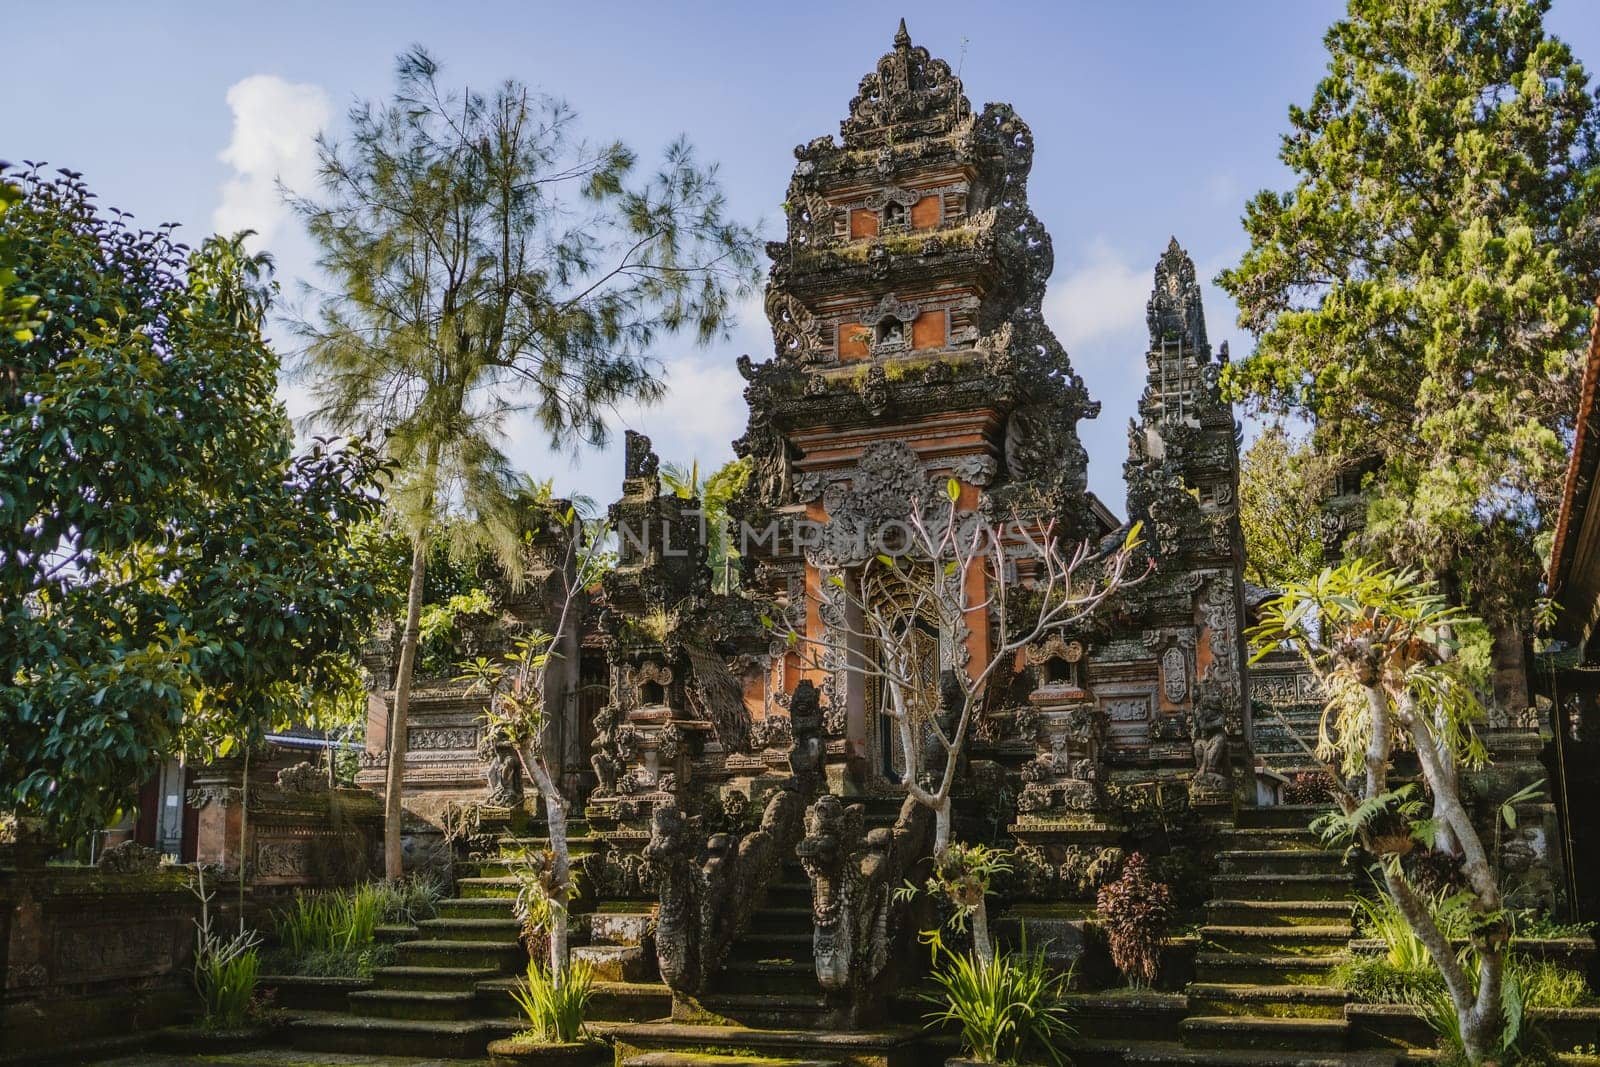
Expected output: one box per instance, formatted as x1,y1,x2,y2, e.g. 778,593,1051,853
923,931,1077,1064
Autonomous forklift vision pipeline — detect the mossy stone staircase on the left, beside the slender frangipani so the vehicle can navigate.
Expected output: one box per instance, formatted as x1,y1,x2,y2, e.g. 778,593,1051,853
291,821,670,1059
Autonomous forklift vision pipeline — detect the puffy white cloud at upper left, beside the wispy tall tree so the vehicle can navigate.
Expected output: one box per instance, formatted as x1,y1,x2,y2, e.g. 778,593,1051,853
211,74,331,248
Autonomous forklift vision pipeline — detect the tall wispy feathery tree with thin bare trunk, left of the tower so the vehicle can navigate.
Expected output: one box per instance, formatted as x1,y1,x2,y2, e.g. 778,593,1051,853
291,48,757,877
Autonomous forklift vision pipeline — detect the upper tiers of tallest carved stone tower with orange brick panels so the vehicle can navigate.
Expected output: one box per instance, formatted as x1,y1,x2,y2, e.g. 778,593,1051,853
734,22,1106,796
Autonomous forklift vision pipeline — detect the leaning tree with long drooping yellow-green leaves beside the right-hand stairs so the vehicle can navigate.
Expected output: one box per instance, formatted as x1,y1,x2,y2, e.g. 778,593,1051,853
1250,560,1528,1064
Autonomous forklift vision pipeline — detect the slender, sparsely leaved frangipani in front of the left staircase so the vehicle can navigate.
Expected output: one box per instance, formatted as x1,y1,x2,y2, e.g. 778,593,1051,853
458,507,606,987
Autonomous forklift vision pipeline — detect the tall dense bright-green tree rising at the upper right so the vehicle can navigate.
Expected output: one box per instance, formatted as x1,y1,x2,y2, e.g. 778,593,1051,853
1218,0,1600,700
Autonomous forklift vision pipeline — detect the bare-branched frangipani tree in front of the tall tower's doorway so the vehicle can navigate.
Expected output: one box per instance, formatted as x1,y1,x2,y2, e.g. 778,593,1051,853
773,480,1147,853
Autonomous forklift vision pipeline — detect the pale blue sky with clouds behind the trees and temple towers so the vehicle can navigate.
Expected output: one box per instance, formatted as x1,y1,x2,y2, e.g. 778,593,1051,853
9,0,1600,512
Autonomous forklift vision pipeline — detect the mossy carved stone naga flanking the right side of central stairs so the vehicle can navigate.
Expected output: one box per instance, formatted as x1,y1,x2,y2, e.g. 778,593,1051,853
795,793,933,1025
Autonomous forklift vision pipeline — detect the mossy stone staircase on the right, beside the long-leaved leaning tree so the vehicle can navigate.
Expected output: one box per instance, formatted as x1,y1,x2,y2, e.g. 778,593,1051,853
1181,805,1352,1062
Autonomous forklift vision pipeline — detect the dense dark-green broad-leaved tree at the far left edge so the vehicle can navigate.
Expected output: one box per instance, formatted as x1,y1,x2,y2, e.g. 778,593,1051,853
0,170,381,835
